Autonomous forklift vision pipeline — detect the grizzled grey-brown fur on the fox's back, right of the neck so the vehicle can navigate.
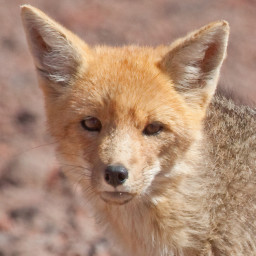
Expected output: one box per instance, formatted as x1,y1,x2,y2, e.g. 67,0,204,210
204,94,256,256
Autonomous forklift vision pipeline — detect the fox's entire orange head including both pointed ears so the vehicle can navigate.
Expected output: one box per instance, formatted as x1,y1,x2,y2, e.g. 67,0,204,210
22,5,229,204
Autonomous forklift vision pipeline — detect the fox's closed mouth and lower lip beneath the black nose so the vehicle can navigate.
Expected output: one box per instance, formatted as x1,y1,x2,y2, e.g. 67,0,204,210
100,191,134,205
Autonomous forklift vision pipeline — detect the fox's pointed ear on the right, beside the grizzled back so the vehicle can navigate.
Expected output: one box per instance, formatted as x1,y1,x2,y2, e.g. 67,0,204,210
158,21,229,108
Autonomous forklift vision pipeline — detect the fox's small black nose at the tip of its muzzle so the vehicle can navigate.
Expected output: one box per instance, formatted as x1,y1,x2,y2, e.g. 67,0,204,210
105,165,128,187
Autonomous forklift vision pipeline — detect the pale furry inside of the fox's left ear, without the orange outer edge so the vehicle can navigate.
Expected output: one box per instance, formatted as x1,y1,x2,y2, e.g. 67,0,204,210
22,5,80,84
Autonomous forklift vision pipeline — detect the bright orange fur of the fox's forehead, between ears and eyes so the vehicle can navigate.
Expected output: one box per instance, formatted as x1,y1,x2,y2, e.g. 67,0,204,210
71,46,193,128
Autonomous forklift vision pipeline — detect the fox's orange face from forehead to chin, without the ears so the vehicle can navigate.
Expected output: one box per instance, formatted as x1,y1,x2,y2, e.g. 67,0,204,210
48,47,199,203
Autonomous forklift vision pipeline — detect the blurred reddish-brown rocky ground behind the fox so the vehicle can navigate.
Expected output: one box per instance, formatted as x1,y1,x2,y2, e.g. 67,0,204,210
0,0,256,256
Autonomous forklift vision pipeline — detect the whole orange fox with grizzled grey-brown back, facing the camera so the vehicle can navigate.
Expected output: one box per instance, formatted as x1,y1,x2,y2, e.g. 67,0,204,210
21,5,256,256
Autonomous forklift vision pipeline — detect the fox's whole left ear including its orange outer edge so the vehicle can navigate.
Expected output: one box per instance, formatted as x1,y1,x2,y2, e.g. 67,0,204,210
21,5,89,91
